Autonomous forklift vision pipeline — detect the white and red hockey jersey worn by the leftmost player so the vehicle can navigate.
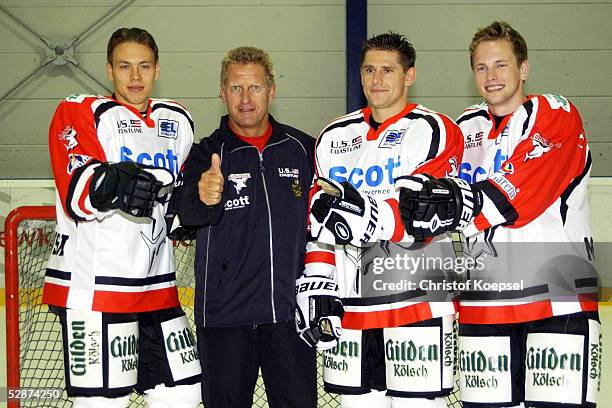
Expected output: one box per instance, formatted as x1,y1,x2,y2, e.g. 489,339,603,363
43,95,193,313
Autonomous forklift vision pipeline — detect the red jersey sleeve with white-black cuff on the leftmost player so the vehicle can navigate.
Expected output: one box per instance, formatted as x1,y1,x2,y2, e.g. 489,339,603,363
49,97,106,221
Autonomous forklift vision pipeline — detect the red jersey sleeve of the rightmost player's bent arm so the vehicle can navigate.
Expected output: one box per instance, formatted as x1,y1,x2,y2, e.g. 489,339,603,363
464,97,591,236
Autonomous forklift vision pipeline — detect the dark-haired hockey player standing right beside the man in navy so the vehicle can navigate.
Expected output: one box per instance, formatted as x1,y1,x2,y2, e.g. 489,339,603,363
296,33,463,408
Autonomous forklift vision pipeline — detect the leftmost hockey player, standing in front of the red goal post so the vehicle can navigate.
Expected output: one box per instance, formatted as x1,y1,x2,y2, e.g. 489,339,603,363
43,28,201,408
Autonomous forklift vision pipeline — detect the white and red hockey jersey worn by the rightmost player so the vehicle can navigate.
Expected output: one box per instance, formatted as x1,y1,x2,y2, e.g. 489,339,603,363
457,95,597,324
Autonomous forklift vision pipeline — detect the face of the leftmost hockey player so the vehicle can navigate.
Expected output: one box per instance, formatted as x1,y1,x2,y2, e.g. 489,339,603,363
106,42,159,112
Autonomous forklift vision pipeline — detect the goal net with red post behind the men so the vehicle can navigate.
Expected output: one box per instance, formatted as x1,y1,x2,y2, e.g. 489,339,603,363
5,206,461,408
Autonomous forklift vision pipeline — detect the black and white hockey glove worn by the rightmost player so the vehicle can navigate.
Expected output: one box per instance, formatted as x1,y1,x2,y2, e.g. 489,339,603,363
395,174,482,241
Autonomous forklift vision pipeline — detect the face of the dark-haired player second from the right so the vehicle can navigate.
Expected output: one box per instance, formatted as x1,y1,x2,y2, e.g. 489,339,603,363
361,50,416,122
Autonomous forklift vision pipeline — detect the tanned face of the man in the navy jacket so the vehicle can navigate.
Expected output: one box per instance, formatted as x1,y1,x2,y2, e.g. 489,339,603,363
221,64,275,136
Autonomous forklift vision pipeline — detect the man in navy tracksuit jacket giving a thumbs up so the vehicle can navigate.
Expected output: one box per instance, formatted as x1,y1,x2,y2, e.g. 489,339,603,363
173,47,317,408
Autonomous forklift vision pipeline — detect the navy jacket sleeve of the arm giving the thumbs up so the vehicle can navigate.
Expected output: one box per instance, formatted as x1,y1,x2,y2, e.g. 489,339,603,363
171,139,225,228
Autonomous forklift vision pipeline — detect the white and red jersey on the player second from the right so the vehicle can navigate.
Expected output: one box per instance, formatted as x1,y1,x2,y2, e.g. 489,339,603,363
305,104,463,329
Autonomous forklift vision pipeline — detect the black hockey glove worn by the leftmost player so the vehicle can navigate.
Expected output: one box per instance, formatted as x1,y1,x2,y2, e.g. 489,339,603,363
89,161,174,217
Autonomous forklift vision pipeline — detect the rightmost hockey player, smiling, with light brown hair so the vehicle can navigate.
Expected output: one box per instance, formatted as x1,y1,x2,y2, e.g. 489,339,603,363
400,21,601,408
